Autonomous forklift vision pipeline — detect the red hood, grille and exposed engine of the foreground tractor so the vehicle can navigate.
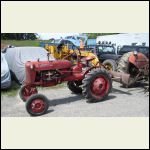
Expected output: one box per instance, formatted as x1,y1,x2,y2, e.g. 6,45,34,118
25,60,72,85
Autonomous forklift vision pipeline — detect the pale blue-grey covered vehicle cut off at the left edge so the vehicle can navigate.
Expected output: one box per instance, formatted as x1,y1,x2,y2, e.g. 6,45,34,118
1,53,11,89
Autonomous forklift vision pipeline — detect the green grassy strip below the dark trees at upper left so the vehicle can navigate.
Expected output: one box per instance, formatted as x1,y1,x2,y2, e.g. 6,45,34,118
1,40,48,46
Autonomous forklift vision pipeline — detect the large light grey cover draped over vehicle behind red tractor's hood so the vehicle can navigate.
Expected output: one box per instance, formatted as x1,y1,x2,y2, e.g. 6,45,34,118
5,47,55,84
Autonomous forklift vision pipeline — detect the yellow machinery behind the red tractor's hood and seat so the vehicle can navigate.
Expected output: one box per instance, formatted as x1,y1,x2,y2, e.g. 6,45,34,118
45,44,100,66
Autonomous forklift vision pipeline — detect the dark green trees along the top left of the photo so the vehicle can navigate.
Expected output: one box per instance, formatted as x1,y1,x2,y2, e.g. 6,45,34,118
1,33,38,40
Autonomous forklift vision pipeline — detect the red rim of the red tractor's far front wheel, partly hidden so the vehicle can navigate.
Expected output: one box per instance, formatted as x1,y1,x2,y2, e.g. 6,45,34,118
22,86,37,100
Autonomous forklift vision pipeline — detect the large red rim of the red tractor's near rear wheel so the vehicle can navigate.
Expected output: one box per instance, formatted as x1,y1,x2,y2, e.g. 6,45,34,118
91,76,109,99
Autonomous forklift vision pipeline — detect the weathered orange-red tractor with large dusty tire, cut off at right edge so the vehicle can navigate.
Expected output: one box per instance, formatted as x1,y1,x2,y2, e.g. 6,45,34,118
109,51,149,88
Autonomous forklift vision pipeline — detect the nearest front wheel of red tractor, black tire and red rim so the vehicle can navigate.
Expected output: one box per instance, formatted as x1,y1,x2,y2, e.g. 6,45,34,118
26,94,49,116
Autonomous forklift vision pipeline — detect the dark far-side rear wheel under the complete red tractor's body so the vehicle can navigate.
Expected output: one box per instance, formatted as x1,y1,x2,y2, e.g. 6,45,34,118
67,81,82,94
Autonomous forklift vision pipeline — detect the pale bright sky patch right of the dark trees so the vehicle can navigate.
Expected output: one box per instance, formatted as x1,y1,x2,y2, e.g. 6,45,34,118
38,33,79,40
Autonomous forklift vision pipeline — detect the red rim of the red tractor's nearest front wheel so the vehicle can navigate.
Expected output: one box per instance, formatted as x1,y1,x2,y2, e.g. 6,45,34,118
29,99,46,113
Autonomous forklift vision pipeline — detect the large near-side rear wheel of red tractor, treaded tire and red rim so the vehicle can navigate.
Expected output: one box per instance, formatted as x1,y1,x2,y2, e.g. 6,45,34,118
82,68,112,102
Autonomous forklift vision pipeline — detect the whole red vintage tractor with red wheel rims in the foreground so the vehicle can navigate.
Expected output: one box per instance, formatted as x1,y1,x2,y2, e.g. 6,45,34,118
19,50,112,116
